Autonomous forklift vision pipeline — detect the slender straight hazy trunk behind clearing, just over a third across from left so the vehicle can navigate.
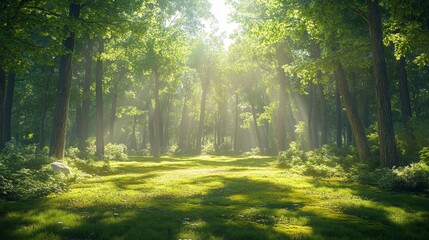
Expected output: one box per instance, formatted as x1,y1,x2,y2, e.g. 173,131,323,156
152,69,161,159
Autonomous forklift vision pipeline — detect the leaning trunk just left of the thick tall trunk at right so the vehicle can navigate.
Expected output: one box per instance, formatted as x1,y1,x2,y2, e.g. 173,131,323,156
335,64,369,160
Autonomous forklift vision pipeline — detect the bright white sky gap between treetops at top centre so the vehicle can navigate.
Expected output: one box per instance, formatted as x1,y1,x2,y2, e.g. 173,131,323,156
208,0,237,48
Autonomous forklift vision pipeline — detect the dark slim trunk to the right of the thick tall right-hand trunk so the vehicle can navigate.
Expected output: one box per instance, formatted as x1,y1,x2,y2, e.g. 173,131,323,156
396,56,412,124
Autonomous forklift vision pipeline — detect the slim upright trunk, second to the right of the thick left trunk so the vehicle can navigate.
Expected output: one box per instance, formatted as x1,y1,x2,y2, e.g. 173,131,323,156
95,39,104,157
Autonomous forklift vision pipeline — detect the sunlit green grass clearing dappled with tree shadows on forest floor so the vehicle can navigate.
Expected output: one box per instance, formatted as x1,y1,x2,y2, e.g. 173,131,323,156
0,156,429,240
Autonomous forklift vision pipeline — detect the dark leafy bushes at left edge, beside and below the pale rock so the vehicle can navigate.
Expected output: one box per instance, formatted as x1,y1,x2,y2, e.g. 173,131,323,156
0,141,72,200
